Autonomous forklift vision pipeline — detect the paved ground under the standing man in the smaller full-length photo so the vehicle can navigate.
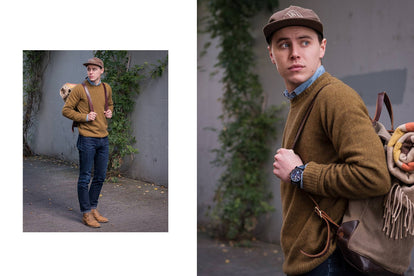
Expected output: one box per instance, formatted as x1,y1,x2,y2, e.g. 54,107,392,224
23,157,168,232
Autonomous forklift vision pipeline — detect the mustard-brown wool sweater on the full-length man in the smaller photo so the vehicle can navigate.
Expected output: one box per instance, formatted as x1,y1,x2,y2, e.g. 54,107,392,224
62,82,114,138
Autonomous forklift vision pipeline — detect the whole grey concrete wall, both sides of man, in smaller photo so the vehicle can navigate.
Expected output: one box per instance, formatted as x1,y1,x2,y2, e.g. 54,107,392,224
29,51,168,186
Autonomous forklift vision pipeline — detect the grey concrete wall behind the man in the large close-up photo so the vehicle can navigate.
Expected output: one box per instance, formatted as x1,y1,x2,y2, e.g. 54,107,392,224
197,0,414,242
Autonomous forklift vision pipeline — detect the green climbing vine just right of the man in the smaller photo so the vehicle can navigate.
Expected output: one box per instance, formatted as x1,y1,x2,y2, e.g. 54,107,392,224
95,51,168,176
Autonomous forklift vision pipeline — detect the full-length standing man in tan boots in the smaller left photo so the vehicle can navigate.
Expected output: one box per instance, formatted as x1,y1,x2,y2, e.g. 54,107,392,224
62,57,113,228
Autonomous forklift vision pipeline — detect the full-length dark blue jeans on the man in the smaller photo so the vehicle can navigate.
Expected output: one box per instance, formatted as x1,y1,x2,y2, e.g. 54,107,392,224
77,135,109,213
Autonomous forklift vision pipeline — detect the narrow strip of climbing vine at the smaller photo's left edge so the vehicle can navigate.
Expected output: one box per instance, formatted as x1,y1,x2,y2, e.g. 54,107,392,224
23,50,49,156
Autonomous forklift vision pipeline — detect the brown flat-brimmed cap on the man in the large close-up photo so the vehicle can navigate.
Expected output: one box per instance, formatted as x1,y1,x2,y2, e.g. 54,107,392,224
263,6,323,44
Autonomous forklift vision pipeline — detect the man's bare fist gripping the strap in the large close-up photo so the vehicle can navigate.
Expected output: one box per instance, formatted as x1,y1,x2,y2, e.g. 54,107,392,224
273,148,303,183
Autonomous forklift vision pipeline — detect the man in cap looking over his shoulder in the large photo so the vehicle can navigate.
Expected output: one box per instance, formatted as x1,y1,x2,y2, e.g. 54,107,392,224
263,6,391,275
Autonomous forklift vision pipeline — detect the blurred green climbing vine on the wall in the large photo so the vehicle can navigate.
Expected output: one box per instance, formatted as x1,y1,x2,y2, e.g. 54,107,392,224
199,0,281,240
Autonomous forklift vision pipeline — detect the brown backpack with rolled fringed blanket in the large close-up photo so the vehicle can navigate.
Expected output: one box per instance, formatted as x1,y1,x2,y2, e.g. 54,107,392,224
292,92,414,275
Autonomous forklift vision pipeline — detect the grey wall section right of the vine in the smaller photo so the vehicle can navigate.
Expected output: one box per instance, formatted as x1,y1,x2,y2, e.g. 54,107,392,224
125,51,168,186
